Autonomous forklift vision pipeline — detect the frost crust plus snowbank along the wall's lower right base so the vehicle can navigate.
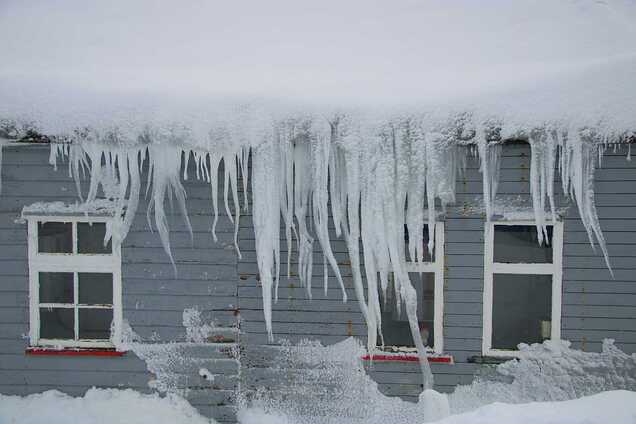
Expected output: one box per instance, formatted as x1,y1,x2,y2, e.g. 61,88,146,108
238,338,636,424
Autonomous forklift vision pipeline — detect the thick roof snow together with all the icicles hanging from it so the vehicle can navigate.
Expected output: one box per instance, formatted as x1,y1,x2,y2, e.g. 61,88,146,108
0,0,636,398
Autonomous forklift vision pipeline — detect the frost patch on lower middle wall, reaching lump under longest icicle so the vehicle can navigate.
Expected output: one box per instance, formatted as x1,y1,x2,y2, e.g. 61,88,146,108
238,338,449,424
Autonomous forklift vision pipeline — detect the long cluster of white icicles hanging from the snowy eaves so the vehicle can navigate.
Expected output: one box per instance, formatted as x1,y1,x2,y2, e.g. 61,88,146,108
50,120,628,388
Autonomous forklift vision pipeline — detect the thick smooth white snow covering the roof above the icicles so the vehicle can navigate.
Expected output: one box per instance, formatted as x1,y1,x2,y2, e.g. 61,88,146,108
0,0,636,140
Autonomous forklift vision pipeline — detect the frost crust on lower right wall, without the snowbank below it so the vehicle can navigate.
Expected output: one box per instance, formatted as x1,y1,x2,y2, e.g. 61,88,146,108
239,338,636,424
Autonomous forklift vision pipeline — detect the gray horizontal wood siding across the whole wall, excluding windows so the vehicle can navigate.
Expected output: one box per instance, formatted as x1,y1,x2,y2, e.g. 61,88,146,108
0,145,636,420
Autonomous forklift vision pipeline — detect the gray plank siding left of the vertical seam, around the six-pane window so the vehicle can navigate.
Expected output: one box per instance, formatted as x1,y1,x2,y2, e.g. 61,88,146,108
0,145,238,422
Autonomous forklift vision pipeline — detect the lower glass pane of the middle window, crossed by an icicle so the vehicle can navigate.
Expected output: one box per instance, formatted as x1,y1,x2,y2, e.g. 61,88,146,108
380,272,435,347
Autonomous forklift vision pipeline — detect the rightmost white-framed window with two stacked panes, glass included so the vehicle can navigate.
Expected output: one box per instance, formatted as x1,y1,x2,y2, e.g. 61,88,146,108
483,221,563,356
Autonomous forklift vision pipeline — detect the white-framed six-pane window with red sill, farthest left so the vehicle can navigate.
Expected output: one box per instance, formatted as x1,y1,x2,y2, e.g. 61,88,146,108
25,216,122,348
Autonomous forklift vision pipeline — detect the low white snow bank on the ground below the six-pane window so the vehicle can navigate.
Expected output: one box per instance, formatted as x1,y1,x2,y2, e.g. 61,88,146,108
0,388,216,424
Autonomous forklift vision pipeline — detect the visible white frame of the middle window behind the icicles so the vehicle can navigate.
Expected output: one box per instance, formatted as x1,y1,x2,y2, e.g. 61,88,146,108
387,221,445,354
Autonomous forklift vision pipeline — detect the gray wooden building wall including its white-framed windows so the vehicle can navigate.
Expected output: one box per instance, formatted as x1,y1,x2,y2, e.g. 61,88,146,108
0,143,636,421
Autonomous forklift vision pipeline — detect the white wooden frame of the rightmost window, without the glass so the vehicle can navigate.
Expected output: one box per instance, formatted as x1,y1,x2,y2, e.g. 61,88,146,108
482,220,563,357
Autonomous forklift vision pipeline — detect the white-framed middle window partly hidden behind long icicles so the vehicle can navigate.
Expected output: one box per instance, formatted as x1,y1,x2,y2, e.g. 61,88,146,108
381,222,444,353
